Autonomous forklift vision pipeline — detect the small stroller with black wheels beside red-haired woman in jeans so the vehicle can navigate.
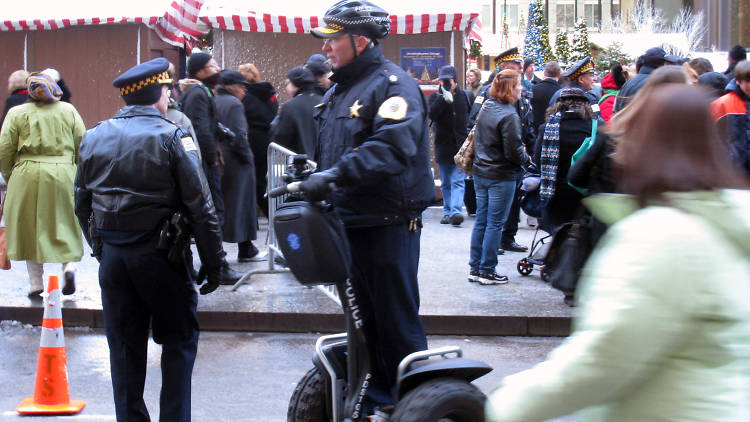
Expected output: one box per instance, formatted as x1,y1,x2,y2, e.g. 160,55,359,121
516,172,554,281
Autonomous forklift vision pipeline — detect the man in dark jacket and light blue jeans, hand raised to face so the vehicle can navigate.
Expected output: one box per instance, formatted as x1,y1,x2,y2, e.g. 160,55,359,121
428,65,471,227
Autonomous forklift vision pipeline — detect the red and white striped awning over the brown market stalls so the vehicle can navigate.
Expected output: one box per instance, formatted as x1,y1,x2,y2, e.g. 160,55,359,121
0,0,482,46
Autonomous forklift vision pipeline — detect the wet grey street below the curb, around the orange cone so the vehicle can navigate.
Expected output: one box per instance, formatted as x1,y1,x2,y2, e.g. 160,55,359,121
0,321,564,422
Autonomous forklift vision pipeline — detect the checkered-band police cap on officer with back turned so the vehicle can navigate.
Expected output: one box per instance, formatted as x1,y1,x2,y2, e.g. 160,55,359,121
112,57,172,105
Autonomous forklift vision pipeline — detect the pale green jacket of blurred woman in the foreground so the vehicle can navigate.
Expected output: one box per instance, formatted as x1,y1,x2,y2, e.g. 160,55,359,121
486,190,750,422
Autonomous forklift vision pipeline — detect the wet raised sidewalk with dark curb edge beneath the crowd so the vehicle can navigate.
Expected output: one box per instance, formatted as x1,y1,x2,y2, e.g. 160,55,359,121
0,206,574,336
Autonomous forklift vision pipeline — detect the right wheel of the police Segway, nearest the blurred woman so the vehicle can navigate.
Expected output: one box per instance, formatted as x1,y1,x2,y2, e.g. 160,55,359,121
390,378,487,422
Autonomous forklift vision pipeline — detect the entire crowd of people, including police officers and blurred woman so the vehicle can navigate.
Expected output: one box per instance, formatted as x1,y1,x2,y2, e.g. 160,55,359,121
0,0,750,421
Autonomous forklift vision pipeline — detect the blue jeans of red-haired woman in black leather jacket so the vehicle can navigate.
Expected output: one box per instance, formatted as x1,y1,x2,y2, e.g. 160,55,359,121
469,174,516,273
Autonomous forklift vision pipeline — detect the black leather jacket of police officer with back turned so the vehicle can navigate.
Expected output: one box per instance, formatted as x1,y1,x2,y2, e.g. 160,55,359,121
75,106,224,269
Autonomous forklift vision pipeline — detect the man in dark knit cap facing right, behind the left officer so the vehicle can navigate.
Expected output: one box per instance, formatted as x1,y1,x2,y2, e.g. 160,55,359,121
180,53,242,284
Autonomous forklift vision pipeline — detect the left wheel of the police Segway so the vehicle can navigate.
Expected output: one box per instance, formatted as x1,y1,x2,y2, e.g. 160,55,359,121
286,368,329,422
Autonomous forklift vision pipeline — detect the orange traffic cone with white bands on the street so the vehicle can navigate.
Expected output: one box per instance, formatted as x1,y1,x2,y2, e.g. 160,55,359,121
16,275,86,415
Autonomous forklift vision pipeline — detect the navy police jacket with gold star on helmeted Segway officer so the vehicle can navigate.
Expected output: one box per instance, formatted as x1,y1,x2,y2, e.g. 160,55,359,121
314,45,435,227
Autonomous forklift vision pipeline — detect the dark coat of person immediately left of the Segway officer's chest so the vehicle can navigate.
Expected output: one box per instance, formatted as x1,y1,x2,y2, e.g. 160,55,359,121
270,86,323,158
